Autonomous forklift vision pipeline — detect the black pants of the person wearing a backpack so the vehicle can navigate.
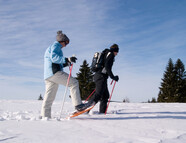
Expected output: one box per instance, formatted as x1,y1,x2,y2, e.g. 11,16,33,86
93,73,109,113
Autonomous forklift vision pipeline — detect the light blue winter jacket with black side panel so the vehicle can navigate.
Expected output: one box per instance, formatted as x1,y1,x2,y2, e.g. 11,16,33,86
44,41,65,79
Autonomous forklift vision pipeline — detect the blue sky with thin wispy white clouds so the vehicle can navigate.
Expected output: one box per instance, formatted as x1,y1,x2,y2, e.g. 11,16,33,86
0,0,186,102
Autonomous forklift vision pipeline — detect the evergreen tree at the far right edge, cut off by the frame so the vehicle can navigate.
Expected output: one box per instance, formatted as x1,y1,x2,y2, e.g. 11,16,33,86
175,59,186,102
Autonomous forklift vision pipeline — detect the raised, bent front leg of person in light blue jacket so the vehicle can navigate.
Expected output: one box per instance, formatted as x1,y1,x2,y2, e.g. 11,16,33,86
50,71,82,106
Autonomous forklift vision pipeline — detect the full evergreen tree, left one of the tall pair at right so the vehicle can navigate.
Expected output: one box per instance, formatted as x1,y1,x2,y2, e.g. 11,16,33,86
158,59,176,102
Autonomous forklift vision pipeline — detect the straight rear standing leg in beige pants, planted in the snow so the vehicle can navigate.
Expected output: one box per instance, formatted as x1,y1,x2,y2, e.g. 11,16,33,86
41,80,58,118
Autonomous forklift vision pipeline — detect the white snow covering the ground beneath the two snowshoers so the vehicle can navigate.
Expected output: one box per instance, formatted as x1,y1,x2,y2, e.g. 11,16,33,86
0,100,186,143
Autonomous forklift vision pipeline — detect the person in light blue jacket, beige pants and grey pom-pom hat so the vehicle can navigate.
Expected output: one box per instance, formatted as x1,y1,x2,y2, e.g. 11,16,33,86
41,31,87,118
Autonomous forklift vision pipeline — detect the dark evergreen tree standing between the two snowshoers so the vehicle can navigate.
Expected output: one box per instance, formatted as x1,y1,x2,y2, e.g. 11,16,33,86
76,60,95,100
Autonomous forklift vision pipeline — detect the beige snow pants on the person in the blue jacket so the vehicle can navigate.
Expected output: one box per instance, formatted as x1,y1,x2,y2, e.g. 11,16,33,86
41,71,82,118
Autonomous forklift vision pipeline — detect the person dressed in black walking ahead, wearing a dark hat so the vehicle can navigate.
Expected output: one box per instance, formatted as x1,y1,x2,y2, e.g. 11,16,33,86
89,44,119,113
